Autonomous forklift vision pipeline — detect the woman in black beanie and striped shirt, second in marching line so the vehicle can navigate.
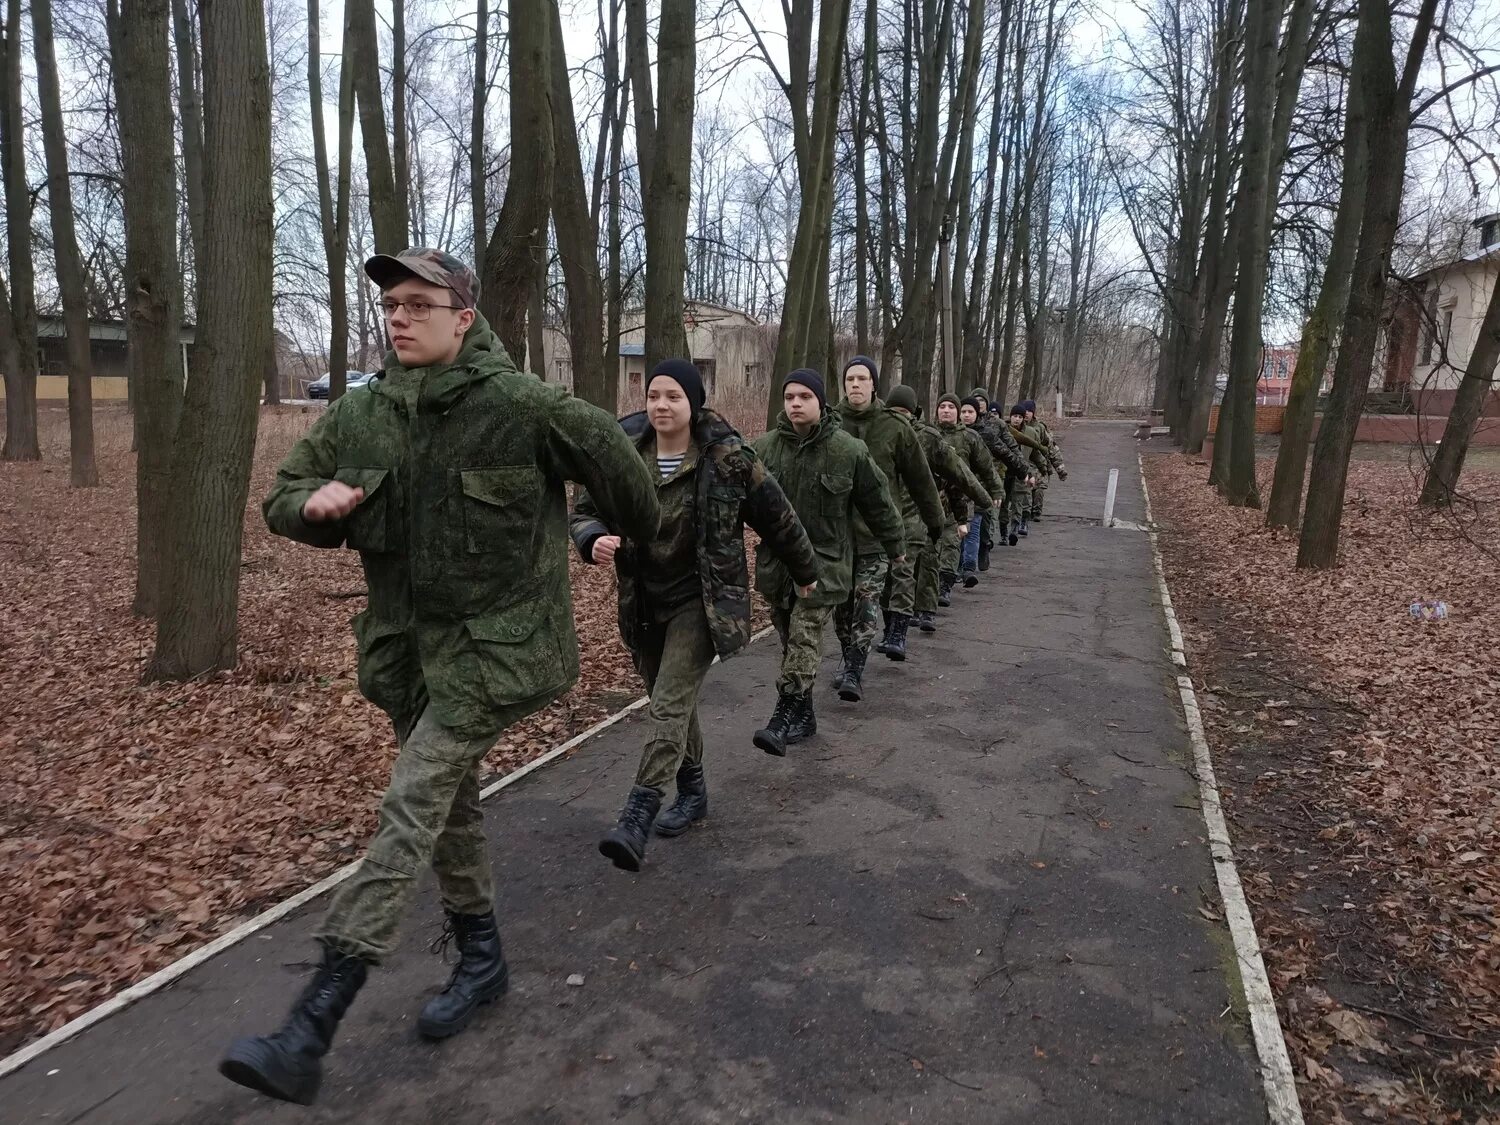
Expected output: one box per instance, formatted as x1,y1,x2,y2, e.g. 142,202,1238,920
572,359,818,872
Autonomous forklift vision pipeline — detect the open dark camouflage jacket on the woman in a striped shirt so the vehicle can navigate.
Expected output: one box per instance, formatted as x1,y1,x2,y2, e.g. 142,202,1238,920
572,410,818,659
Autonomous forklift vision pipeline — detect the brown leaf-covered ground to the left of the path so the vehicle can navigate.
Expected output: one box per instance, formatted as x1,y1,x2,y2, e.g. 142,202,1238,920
0,407,762,1053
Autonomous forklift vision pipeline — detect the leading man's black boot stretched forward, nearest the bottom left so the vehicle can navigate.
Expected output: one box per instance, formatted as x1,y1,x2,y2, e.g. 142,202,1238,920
219,947,368,1106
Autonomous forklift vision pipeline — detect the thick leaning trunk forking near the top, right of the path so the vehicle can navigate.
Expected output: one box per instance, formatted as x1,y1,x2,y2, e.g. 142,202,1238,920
1298,0,1437,569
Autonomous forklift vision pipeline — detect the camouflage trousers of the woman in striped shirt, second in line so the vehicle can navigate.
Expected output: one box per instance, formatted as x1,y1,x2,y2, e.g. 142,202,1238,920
636,600,714,795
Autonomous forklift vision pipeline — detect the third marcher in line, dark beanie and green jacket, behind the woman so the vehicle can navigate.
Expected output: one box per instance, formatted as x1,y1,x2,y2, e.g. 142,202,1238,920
753,368,900,756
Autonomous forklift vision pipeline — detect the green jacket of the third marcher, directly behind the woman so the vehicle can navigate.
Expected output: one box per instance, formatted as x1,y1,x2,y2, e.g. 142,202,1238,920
753,411,900,606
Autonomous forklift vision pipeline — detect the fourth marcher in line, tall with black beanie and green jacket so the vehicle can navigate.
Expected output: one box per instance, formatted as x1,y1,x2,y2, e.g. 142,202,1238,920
834,356,948,675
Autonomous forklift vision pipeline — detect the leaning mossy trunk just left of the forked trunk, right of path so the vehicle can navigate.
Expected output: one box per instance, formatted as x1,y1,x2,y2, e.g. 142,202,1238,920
1266,79,1370,528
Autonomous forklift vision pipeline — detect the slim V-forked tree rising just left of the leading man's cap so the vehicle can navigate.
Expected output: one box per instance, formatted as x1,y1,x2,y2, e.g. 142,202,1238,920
308,0,354,402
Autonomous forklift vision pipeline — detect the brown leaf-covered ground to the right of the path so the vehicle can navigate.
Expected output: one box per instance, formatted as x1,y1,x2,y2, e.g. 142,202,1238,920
1146,456,1500,1122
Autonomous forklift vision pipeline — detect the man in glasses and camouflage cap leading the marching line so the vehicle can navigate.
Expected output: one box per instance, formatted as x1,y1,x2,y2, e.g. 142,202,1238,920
219,249,659,1104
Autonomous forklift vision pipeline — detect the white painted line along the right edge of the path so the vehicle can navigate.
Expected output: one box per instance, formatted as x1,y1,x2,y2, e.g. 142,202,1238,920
1137,455,1302,1125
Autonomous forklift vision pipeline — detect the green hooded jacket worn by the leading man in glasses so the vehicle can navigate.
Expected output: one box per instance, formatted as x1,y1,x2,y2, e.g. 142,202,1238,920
263,317,659,738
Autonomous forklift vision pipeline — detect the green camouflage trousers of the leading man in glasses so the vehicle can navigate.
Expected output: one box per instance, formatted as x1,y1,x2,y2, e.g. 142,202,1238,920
318,708,500,962
